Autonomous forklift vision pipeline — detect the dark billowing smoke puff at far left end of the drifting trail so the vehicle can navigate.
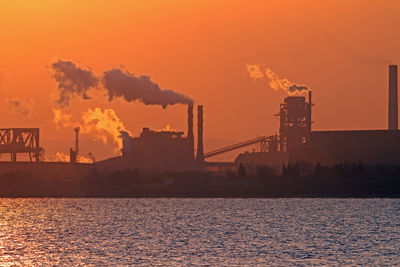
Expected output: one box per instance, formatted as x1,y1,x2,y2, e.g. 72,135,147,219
51,59,98,106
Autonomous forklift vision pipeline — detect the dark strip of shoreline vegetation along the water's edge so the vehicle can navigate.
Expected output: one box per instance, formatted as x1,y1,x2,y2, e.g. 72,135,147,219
0,163,400,198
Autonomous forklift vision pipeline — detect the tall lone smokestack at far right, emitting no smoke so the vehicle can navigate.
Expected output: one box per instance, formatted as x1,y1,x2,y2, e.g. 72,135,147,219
388,65,398,130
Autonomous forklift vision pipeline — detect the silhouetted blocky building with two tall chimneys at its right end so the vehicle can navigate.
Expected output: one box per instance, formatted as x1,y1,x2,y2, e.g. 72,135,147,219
96,104,204,171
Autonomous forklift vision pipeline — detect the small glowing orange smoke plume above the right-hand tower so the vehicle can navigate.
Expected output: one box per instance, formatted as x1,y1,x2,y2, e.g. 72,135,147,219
246,64,311,95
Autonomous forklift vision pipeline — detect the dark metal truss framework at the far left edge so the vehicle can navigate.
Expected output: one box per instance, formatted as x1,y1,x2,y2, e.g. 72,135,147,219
0,128,40,162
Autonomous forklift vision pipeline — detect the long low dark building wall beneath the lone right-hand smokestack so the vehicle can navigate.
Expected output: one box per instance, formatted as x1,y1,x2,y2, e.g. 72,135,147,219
290,130,400,165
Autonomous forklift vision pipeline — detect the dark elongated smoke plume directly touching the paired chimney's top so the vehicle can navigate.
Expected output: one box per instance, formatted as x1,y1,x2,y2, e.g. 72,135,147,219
104,69,193,108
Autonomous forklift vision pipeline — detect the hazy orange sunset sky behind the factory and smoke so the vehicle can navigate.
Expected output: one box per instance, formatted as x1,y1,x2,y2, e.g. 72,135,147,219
0,0,400,159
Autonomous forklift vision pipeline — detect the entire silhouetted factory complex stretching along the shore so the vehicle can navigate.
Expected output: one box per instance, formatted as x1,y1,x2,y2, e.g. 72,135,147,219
0,65,400,176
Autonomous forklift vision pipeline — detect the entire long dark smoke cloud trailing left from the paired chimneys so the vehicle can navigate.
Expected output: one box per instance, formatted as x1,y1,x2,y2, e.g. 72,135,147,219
51,59,193,108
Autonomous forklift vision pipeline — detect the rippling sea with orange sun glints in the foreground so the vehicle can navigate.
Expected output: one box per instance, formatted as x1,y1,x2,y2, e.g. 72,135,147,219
0,198,400,266
